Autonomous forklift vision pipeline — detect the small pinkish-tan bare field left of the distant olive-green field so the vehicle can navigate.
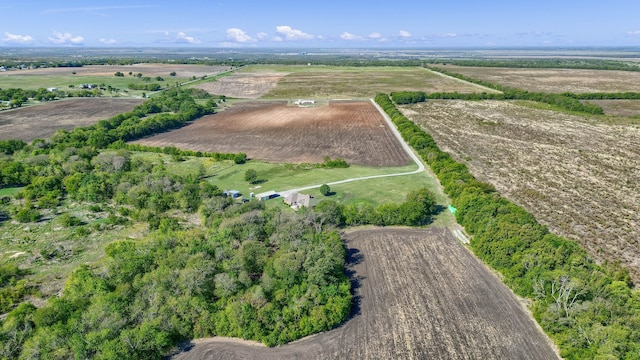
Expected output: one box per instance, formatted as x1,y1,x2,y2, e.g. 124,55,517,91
194,72,287,99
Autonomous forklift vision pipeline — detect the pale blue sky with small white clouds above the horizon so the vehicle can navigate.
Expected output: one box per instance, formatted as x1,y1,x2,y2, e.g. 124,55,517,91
0,0,640,48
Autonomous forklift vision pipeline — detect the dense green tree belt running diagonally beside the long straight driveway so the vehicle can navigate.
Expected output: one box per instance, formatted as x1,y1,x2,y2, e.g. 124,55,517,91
375,94,640,359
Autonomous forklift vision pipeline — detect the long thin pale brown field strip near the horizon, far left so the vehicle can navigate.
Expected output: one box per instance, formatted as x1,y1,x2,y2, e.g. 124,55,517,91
2,64,230,80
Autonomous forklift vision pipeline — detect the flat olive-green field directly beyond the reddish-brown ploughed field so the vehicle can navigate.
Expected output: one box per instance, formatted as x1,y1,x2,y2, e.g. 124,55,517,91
240,65,486,99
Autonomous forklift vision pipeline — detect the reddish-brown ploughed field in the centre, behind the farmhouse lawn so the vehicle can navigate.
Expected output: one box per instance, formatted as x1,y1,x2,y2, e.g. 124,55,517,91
135,102,410,166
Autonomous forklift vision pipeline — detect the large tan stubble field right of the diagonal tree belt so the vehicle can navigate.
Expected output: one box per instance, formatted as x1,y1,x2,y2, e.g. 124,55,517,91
402,101,640,283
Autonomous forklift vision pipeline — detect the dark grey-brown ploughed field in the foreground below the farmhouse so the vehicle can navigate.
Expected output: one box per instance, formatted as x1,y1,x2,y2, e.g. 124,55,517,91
174,228,558,360
